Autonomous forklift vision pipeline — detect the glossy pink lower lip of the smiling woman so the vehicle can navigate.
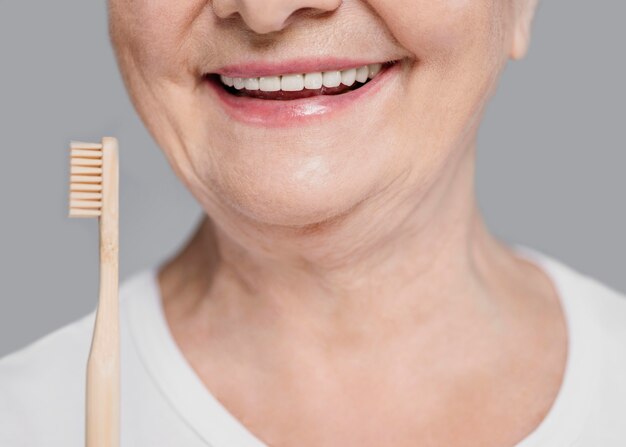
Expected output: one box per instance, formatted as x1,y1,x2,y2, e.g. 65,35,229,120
205,63,400,127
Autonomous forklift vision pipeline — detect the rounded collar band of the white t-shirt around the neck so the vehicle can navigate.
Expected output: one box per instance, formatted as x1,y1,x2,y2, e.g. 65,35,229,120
126,244,597,447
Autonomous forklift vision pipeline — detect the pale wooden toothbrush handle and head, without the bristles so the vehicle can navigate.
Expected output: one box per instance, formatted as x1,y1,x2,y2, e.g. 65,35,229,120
85,137,120,447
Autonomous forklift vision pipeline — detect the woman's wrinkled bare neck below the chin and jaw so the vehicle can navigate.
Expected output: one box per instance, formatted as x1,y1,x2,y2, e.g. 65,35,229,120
160,144,514,346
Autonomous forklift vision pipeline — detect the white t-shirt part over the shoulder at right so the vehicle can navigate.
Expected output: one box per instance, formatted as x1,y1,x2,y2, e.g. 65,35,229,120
514,244,626,447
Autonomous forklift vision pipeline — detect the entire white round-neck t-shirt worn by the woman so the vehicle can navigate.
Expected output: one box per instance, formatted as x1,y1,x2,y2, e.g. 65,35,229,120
0,244,626,447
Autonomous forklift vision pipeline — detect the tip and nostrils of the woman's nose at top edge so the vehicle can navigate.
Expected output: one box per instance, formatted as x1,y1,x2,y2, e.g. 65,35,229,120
213,0,342,34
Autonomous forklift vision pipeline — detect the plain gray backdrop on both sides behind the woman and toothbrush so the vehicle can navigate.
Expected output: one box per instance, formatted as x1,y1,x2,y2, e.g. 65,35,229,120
0,0,626,356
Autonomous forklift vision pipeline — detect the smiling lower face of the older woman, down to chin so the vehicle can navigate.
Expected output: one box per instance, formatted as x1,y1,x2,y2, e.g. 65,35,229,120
110,0,530,225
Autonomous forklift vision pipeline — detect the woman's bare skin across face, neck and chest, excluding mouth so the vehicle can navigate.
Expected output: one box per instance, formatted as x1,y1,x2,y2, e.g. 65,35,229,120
109,0,567,447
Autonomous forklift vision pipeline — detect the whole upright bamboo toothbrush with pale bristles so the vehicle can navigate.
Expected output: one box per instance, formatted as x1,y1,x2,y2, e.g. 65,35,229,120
69,137,120,447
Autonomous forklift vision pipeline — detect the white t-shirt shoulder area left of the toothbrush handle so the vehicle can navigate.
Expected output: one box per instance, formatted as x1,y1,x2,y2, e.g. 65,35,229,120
0,312,94,446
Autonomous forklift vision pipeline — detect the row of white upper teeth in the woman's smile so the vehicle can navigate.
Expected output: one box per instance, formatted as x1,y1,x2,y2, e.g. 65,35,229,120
220,64,382,92
